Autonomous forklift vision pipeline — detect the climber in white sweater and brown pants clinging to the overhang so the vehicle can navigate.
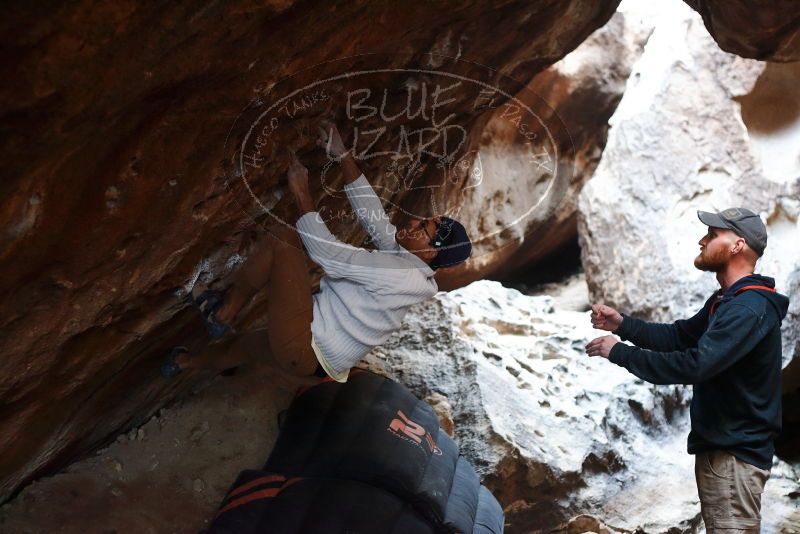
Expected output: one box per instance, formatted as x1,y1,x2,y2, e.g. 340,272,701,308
162,123,472,381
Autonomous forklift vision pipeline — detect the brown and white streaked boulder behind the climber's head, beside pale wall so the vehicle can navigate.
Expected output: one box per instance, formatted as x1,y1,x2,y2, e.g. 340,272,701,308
446,6,654,282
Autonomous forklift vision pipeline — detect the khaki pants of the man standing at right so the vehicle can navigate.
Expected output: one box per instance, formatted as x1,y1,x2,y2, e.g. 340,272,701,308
694,451,769,534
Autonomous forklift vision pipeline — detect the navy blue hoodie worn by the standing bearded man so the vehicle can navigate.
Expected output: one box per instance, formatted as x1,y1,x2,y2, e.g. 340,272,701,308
608,274,789,469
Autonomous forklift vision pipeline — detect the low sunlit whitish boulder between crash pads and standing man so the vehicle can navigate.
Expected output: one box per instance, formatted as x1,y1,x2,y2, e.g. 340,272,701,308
368,281,800,533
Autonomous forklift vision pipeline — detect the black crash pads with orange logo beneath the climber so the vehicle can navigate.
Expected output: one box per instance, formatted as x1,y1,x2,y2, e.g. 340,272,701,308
208,372,504,534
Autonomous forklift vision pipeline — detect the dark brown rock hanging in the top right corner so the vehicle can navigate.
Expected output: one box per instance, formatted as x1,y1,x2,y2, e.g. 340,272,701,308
684,0,800,61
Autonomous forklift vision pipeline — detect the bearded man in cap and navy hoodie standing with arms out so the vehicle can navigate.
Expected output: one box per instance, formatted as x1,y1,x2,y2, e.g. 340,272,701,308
586,208,789,533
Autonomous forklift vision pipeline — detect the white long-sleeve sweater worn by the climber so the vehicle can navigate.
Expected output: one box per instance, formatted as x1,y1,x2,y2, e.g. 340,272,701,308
297,174,438,373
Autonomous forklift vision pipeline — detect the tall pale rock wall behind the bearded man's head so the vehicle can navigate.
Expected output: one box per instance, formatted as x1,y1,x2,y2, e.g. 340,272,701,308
579,3,800,360
